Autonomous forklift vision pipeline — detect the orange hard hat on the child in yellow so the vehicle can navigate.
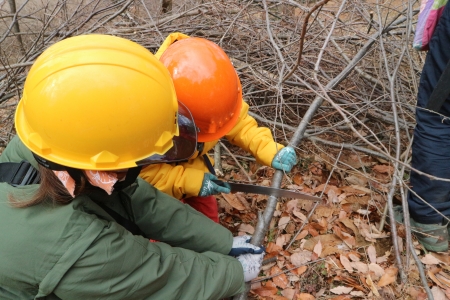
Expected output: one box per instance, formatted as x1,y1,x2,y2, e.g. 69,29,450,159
160,37,242,142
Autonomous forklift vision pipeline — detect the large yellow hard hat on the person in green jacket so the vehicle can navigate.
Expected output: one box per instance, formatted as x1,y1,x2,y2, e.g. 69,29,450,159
15,34,196,170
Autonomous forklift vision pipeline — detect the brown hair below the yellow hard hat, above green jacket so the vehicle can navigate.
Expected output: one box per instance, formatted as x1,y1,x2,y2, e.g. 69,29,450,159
9,165,86,208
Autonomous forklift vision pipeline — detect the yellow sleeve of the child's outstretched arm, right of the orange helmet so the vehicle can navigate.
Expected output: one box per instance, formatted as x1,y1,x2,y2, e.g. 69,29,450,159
225,102,284,166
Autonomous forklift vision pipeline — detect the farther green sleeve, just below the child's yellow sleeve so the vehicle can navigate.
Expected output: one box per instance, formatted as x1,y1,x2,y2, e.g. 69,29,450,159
130,178,233,254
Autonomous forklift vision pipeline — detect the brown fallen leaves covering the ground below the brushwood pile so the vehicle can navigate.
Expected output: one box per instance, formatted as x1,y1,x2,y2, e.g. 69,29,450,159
218,144,450,300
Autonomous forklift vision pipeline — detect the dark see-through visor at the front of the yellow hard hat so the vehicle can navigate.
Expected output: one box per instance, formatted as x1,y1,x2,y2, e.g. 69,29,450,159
136,102,198,166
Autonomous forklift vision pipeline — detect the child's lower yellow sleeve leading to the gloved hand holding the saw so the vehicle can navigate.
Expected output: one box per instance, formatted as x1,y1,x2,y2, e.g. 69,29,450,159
139,164,205,199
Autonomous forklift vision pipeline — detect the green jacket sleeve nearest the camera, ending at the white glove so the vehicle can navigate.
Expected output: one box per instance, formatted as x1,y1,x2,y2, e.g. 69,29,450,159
49,220,244,300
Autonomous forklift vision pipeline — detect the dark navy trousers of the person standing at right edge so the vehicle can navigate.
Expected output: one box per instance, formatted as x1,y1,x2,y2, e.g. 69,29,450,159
408,2,450,224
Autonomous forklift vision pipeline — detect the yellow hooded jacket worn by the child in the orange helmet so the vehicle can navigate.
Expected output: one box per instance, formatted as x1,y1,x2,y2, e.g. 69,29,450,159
140,33,284,199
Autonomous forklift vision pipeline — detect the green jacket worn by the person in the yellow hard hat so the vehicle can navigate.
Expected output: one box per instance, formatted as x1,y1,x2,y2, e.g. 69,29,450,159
0,137,244,300
